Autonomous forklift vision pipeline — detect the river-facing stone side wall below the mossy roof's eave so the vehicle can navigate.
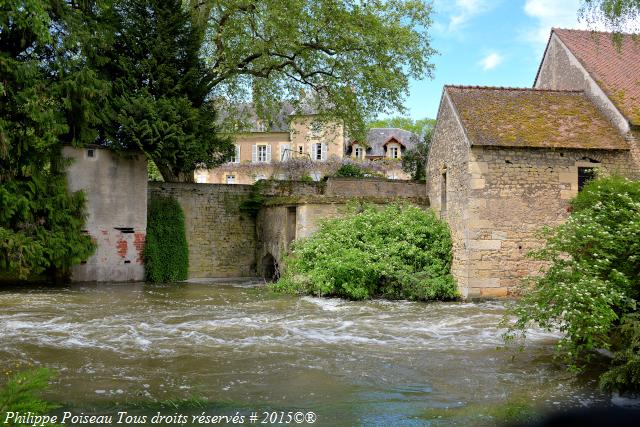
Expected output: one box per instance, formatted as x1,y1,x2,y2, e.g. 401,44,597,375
466,147,632,297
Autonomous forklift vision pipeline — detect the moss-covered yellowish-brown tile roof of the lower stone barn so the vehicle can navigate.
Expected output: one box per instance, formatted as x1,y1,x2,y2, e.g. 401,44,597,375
445,86,629,150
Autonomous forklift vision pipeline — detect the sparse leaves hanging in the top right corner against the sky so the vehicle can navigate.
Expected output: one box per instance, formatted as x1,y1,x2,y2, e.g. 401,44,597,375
579,0,640,34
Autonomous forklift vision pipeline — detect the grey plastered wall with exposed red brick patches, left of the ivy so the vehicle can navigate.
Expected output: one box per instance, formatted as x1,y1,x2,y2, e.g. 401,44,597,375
63,147,147,282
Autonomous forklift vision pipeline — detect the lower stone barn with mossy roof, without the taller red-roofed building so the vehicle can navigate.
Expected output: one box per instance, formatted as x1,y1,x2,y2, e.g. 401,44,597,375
427,86,634,297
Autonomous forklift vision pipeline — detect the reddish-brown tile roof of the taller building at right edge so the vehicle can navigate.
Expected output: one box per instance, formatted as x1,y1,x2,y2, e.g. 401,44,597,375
551,28,640,126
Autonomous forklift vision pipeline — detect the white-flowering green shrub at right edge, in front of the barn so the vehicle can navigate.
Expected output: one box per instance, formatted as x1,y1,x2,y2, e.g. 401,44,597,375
509,177,640,390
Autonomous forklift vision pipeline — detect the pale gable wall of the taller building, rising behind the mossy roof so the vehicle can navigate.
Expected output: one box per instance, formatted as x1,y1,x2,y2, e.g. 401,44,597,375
534,34,640,178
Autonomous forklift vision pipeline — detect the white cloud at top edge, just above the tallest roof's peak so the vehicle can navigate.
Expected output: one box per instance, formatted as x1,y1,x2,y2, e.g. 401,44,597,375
524,0,598,45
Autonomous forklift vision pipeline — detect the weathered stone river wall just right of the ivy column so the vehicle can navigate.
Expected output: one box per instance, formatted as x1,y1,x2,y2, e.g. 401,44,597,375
149,183,256,278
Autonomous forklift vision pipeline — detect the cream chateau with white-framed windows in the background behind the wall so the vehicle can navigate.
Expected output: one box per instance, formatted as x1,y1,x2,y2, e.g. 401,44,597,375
195,104,417,184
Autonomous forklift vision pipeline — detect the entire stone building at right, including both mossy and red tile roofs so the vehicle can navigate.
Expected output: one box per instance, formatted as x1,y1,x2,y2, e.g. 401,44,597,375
427,29,640,297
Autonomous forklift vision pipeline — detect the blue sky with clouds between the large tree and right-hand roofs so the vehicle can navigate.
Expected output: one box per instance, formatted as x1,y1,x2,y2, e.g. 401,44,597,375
395,0,604,119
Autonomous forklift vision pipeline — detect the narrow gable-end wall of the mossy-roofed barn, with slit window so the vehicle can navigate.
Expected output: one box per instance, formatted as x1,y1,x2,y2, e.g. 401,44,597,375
427,92,472,297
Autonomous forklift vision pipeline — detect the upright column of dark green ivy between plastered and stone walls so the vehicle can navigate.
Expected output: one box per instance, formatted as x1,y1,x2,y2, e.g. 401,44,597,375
144,196,189,282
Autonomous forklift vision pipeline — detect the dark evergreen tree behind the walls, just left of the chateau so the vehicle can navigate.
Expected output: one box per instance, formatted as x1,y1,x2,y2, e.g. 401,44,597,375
91,0,233,181
